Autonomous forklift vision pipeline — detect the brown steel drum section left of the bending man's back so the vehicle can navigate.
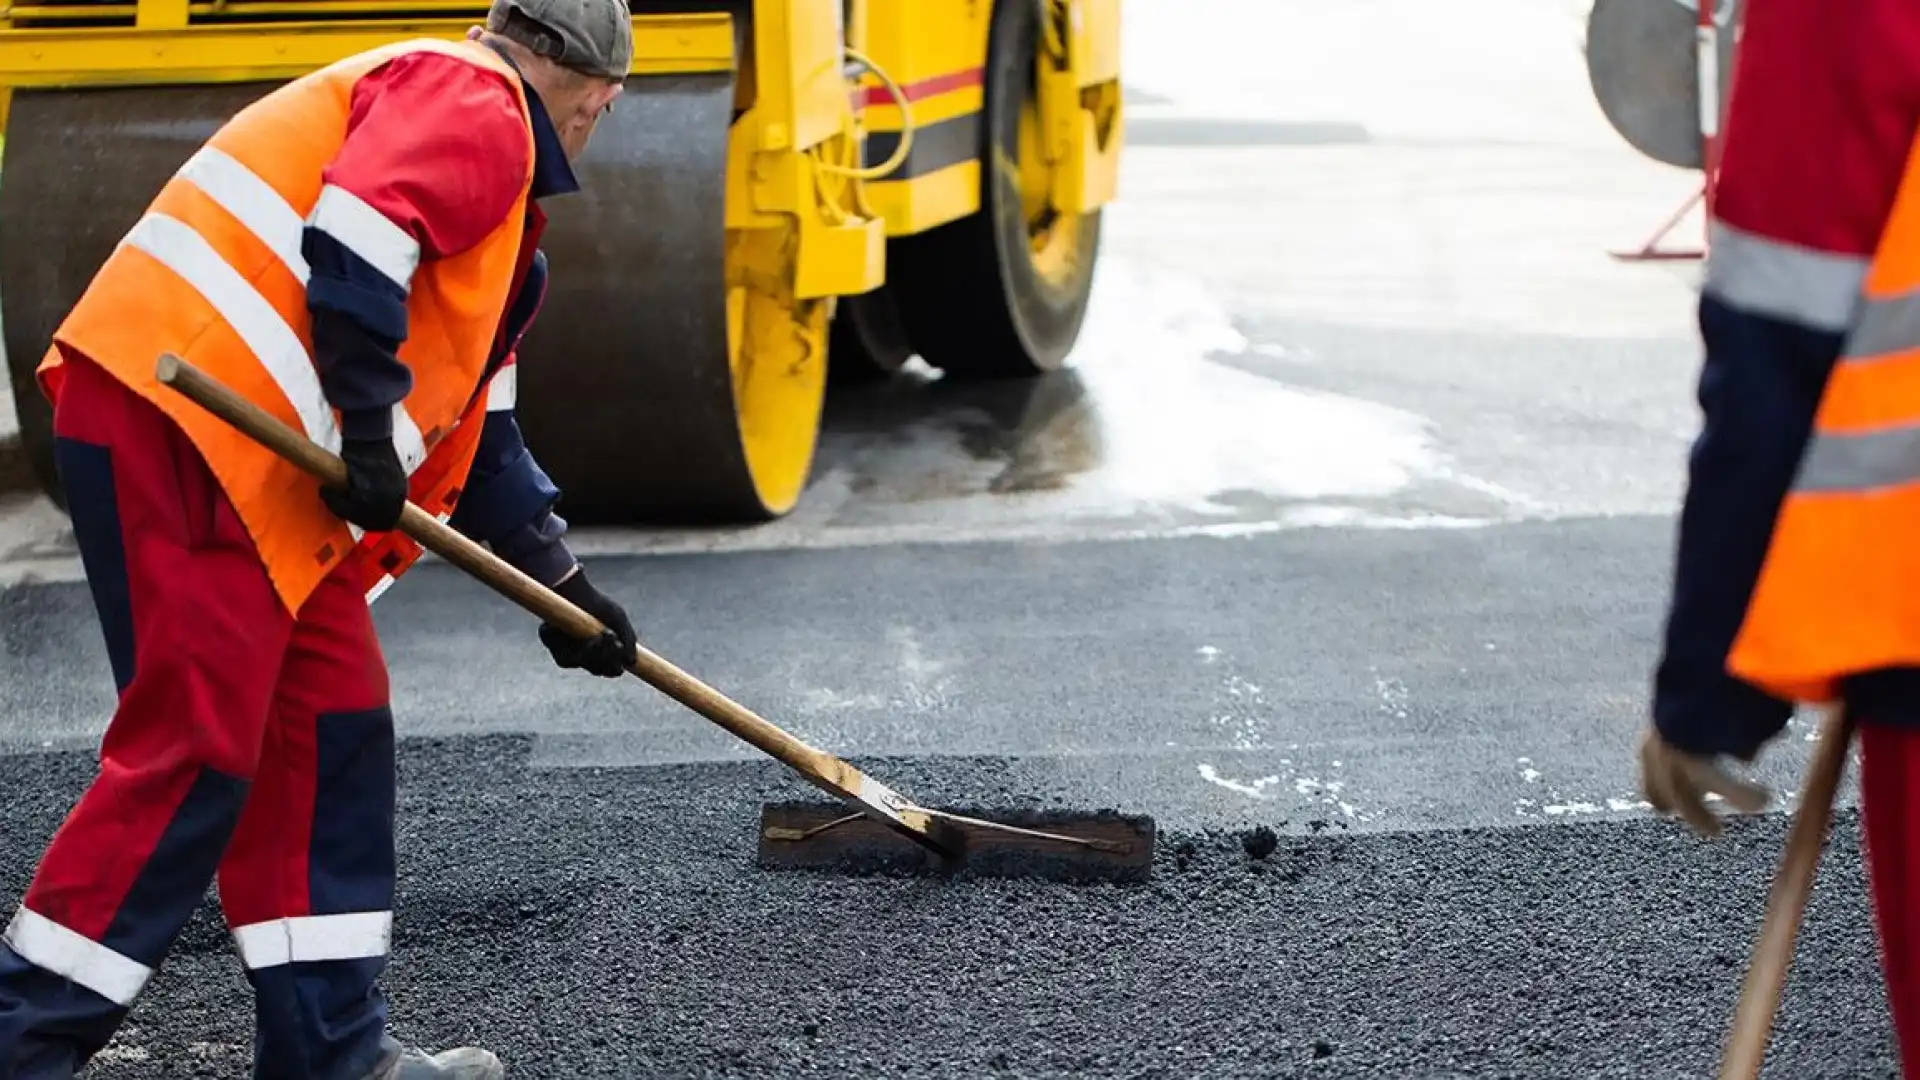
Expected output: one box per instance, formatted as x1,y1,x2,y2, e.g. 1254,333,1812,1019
0,83,276,503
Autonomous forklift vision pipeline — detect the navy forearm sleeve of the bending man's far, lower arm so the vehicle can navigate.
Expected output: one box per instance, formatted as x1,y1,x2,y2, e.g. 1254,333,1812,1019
447,409,574,584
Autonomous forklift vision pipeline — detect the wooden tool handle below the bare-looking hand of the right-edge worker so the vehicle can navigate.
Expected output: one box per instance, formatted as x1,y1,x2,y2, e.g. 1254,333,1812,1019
1720,707,1853,1080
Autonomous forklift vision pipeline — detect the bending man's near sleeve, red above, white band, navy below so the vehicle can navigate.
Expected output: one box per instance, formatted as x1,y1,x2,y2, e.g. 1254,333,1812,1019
301,52,534,438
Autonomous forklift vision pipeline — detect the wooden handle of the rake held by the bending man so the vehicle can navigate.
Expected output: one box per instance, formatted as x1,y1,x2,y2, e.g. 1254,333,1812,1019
156,354,860,798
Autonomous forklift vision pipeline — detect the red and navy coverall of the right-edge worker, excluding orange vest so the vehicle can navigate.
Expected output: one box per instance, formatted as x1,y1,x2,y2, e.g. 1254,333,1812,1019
1653,0,1920,1070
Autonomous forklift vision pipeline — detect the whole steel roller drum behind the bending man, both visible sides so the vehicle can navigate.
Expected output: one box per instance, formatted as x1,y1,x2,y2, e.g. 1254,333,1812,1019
0,12,828,523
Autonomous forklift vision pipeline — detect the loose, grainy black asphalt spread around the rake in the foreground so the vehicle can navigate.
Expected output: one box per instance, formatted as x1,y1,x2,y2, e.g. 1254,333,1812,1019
0,736,1897,1078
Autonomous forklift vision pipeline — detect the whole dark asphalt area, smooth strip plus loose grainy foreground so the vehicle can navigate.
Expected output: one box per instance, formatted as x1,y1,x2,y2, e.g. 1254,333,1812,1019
0,519,1895,1078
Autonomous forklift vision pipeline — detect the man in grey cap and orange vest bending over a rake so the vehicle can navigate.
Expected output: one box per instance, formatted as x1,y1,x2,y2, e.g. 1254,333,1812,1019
0,0,636,1080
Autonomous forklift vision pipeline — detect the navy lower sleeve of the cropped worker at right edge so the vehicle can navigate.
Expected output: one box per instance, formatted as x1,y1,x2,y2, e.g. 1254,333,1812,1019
1653,294,1843,761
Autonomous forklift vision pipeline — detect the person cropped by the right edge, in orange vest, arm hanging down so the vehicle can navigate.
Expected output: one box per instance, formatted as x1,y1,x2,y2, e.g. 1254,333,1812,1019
1640,0,1920,1076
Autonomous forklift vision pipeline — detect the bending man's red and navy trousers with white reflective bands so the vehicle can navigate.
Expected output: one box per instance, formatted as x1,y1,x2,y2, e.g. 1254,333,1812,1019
0,357,396,1080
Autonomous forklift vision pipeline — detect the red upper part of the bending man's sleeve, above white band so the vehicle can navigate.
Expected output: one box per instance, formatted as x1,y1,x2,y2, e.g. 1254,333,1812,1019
323,52,534,259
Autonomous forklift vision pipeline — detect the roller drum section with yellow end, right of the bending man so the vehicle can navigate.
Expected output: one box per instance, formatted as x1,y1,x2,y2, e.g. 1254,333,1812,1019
516,61,828,525
